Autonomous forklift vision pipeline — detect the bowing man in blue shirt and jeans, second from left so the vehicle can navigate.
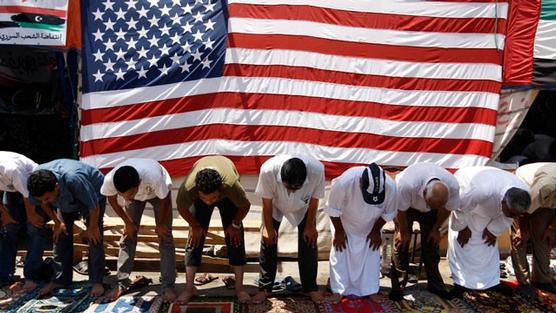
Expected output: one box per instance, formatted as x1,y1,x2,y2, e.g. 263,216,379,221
27,159,106,297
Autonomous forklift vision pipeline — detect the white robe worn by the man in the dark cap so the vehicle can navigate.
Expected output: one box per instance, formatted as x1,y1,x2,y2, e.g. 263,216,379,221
325,167,397,296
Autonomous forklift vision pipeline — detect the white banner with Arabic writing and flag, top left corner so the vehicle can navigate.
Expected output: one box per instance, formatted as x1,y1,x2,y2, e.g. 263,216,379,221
0,0,68,46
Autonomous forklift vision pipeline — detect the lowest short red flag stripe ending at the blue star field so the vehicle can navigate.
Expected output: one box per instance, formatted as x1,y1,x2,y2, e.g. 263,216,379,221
224,63,502,94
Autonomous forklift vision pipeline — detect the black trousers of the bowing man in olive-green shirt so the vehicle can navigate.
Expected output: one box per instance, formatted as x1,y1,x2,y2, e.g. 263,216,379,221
185,198,246,267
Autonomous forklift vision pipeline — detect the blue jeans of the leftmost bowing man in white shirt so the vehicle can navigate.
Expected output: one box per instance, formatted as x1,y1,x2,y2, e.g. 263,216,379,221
0,192,48,284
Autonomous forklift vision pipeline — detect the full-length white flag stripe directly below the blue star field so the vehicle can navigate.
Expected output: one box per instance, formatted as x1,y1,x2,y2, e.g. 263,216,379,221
83,76,499,110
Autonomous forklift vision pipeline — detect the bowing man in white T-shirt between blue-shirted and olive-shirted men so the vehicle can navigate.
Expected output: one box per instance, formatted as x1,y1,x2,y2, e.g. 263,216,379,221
100,159,176,302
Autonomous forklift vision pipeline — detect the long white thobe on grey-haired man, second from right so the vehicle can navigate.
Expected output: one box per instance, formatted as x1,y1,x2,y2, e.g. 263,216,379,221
448,167,529,290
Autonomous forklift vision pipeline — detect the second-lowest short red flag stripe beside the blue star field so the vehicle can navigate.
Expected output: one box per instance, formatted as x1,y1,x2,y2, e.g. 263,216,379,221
228,33,502,64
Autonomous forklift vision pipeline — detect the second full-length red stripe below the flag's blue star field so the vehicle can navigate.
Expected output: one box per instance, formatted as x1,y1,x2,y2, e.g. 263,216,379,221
81,124,492,157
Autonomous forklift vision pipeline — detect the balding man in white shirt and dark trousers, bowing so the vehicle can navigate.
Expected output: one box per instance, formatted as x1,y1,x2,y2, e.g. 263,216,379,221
389,163,460,301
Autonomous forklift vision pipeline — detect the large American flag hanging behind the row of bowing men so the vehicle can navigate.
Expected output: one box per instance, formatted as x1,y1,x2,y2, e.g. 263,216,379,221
81,0,508,177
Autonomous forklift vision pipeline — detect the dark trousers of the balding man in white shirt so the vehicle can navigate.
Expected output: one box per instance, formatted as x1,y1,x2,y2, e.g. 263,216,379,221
390,208,446,290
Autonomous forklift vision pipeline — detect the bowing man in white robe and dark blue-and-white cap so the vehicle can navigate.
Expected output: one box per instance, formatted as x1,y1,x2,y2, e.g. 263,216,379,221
326,163,397,302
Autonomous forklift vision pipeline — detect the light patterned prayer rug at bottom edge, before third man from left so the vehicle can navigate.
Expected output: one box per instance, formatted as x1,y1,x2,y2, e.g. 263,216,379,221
84,296,166,313
